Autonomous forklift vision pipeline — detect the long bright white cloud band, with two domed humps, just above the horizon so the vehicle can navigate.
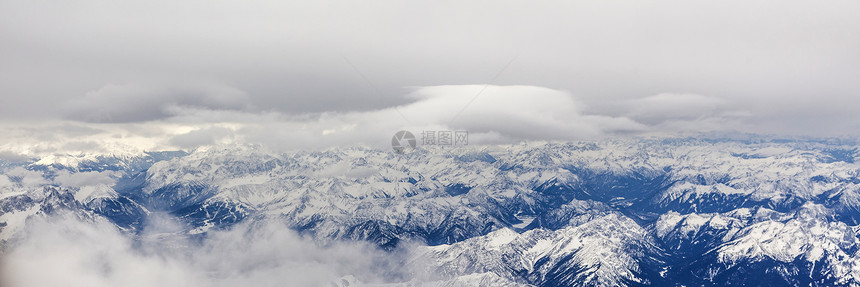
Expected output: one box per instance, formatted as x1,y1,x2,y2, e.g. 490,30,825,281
0,85,760,158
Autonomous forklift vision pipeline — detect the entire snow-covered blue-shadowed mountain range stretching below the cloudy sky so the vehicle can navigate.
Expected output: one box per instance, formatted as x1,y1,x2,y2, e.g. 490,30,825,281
0,137,860,286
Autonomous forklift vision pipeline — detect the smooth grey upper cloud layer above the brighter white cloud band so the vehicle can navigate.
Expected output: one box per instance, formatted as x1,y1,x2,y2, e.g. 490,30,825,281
0,0,860,135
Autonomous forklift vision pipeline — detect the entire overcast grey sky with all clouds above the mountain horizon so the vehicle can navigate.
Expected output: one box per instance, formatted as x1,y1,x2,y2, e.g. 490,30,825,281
0,0,860,153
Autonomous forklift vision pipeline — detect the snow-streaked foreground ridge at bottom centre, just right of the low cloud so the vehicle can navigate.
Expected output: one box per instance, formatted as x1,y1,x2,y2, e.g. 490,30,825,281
416,214,660,286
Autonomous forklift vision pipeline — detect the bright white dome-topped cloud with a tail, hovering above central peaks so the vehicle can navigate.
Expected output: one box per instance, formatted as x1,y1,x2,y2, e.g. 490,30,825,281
395,85,644,139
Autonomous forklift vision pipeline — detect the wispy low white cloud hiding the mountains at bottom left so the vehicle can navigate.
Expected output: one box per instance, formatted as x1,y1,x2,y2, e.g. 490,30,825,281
0,217,416,287
